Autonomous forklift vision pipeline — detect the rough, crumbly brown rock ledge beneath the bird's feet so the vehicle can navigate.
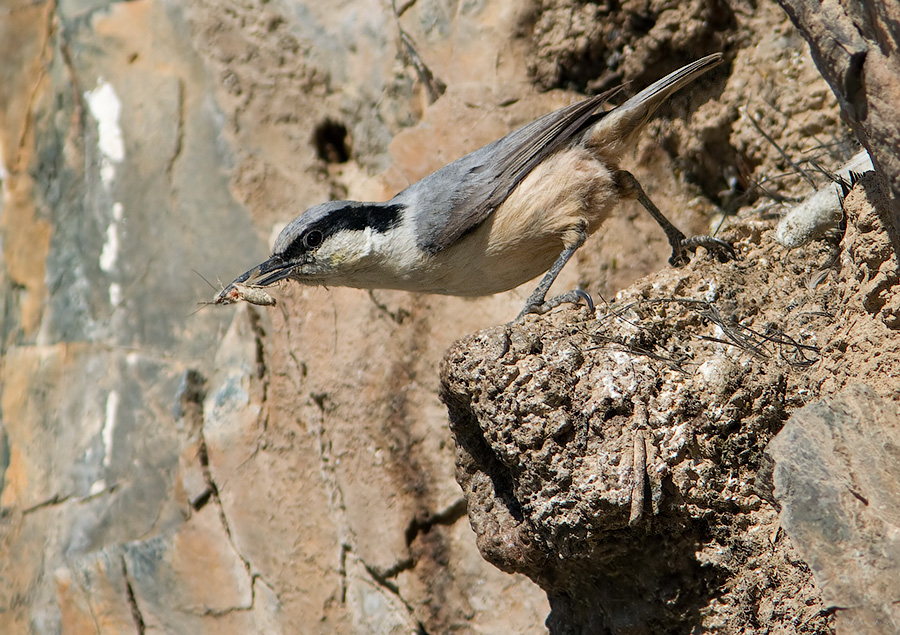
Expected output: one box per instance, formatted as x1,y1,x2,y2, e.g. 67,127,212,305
442,173,900,633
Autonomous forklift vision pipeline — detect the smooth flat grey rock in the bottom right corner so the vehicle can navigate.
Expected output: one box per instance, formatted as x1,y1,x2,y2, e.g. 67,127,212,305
768,385,900,634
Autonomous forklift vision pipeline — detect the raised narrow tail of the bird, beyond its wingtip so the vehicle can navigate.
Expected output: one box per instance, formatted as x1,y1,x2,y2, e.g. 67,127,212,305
584,53,722,157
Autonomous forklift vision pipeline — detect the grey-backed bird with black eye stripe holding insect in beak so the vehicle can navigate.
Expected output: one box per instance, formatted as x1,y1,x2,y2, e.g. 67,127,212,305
216,53,735,320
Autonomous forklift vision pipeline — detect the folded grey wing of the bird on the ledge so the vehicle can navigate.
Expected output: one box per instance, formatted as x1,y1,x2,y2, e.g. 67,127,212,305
408,89,618,254
